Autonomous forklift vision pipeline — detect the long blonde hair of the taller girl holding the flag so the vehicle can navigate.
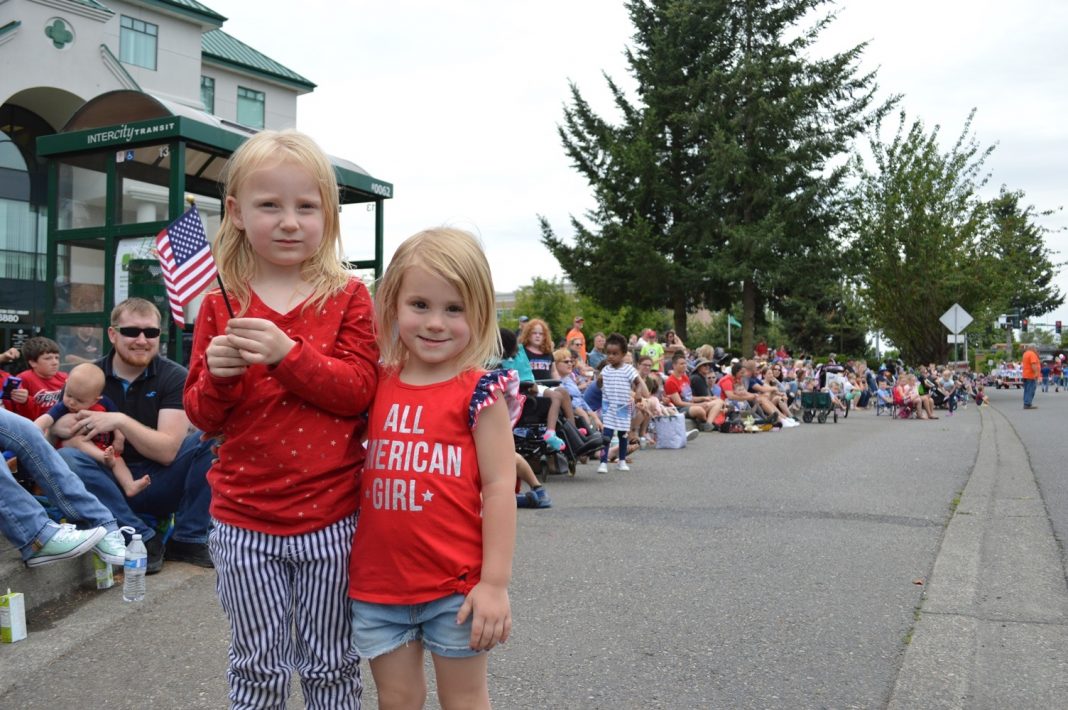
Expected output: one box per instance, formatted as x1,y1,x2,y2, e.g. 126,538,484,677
211,129,349,315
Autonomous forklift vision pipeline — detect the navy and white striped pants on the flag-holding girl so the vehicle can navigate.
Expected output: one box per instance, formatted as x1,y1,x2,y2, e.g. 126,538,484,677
208,516,363,710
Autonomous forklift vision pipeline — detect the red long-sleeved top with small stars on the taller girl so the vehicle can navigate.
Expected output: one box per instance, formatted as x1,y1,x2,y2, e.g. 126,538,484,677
183,279,378,535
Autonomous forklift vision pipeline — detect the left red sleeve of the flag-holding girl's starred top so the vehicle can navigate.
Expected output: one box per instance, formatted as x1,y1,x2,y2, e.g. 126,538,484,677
182,290,245,433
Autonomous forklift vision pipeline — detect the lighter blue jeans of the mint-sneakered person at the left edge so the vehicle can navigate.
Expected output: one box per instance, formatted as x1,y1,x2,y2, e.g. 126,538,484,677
0,409,119,559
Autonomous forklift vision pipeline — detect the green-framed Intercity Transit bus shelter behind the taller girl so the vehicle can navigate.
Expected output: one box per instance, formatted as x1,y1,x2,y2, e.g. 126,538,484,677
37,91,393,362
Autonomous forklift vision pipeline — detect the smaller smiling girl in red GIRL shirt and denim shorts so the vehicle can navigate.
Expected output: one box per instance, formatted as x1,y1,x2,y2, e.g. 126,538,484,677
349,228,521,709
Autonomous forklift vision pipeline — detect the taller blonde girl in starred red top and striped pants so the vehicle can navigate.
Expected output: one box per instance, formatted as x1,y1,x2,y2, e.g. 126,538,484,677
185,130,378,710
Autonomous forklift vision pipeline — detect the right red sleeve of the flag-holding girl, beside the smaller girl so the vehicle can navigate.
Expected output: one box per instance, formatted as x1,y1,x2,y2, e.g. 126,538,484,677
271,279,378,416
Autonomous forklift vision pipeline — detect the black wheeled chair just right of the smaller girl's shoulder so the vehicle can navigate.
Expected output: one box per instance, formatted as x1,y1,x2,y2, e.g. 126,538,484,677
512,396,603,480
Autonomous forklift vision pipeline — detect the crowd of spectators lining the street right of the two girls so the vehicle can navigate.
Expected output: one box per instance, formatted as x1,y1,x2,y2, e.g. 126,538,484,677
506,316,995,476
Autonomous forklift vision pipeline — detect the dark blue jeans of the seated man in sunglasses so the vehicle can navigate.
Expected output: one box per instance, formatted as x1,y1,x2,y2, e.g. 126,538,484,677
60,431,215,542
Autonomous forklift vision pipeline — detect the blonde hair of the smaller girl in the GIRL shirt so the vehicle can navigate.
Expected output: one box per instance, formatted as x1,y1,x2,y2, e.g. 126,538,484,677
375,227,502,370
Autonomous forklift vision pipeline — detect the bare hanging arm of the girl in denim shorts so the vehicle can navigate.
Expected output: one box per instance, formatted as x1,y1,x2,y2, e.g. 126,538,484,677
456,398,516,650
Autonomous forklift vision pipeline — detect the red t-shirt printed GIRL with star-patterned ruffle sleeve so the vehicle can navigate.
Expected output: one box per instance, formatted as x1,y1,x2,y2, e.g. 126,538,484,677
348,370,521,604
